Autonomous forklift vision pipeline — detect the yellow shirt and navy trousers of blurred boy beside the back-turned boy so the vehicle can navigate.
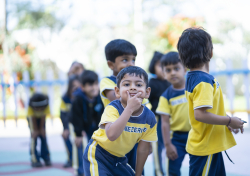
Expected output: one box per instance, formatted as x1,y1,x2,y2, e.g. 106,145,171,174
156,86,191,176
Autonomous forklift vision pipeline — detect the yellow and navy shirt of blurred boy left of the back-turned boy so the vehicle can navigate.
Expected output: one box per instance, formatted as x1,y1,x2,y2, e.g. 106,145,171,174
156,86,191,132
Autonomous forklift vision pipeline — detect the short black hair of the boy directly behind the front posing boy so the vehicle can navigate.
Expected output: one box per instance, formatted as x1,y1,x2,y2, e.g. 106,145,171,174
105,39,137,62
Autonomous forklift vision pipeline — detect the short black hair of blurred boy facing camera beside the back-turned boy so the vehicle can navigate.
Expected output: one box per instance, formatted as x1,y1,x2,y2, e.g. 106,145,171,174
161,51,181,67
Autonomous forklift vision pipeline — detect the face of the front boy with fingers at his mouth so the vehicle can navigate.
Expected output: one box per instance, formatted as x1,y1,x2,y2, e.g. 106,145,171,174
115,74,151,105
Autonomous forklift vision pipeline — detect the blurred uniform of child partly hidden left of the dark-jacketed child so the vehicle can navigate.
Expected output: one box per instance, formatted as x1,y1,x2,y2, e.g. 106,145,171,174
60,95,72,163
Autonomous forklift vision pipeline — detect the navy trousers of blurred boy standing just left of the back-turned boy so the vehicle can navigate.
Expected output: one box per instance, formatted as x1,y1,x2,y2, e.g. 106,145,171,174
168,132,188,176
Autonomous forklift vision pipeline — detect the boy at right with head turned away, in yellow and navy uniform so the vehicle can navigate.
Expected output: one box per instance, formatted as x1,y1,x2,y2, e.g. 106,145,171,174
177,28,243,176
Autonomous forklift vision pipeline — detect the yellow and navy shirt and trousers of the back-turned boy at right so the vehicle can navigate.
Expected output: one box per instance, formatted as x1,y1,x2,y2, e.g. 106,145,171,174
186,71,236,176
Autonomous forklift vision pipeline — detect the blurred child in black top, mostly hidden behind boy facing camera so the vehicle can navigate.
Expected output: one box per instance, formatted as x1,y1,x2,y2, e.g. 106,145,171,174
149,51,170,176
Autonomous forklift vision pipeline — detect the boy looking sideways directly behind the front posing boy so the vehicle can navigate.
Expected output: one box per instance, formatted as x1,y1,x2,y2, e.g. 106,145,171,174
100,39,148,172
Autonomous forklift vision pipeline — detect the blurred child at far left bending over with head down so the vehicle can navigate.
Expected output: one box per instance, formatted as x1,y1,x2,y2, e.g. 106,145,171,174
27,93,51,167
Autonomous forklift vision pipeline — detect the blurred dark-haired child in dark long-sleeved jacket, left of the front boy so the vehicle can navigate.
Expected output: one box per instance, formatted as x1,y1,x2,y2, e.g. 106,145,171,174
70,70,104,175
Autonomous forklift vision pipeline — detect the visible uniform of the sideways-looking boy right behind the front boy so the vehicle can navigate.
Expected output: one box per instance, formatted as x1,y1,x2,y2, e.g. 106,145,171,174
100,75,148,173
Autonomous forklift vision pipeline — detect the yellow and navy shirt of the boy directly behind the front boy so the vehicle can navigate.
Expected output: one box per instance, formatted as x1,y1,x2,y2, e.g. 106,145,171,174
100,75,148,107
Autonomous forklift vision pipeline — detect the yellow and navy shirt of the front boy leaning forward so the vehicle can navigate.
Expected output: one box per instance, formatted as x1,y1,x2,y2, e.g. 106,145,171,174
92,100,158,157
